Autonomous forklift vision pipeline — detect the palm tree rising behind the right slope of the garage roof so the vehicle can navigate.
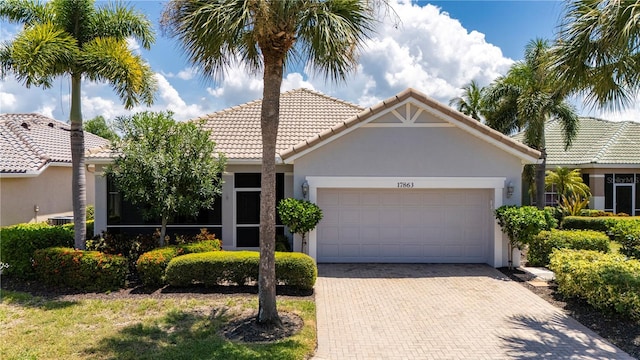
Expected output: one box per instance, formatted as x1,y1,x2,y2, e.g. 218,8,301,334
486,39,579,209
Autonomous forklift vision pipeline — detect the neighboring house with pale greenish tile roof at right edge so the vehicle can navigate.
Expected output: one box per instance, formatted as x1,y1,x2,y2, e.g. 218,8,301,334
514,118,640,215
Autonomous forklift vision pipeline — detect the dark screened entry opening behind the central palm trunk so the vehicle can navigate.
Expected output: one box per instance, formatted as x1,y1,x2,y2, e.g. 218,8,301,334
234,173,284,247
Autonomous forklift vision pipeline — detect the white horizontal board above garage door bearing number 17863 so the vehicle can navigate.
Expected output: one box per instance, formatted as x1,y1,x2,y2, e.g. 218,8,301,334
305,176,506,189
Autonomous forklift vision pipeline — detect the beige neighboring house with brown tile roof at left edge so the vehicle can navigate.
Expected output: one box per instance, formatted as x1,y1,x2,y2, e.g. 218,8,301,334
0,114,109,226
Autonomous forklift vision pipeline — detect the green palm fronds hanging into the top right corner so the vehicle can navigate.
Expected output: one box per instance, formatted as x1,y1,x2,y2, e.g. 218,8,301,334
551,0,640,108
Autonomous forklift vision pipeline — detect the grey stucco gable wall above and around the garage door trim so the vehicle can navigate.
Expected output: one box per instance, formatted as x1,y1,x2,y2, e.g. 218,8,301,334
294,127,522,204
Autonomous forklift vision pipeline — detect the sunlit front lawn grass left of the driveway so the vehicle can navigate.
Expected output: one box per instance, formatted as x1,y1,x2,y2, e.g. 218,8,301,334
0,291,316,360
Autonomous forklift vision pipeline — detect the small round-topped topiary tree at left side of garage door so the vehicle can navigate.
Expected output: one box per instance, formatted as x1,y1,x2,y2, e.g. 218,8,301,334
278,198,322,252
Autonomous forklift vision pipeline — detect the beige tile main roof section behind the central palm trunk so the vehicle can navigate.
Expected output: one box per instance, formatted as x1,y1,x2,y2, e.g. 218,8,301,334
191,89,363,160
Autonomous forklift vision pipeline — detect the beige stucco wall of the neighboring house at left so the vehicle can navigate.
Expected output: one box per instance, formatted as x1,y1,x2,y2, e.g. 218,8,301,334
0,166,95,226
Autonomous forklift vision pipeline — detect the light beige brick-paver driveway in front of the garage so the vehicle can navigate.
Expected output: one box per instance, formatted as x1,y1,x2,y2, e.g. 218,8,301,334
315,264,631,360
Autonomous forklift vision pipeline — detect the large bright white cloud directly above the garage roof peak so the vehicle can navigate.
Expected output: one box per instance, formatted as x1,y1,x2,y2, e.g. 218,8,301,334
313,3,513,105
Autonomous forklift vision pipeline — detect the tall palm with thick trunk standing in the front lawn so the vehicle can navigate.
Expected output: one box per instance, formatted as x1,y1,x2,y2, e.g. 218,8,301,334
162,0,376,326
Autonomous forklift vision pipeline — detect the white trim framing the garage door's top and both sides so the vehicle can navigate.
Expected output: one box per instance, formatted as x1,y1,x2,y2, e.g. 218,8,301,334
305,176,507,267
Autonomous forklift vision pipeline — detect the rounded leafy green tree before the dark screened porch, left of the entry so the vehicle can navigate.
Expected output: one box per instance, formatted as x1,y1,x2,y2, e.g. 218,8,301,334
107,112,226,246
